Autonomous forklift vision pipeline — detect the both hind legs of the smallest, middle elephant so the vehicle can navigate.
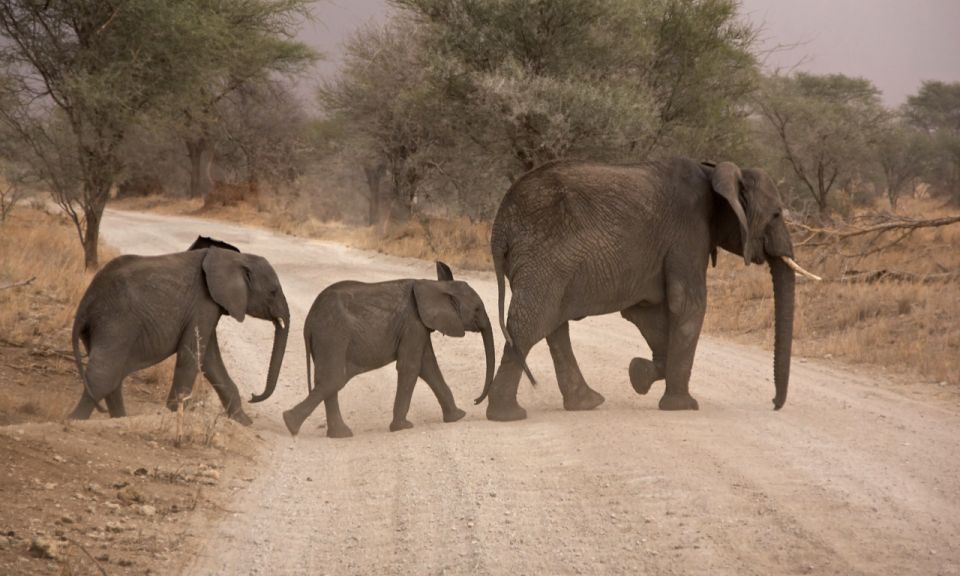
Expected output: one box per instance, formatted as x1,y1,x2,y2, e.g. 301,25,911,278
283,348,353,438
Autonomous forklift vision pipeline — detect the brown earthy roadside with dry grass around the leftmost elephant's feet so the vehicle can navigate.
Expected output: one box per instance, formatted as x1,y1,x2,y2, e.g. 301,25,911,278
0,207,262,575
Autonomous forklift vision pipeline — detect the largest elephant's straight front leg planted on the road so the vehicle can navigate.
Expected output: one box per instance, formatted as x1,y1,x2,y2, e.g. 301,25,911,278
660,279,706,410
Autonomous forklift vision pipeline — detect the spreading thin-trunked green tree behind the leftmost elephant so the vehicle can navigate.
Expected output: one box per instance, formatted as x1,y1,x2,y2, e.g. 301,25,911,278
0,0,312,268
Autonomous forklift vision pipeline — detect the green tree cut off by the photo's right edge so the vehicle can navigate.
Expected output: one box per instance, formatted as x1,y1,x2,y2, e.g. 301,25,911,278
904,81,960,206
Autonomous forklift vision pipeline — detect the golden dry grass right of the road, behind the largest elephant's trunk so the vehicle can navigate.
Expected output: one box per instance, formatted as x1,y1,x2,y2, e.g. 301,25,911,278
705,200,960,384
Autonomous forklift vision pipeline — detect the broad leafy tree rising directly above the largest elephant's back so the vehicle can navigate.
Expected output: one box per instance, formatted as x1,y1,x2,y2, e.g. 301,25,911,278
393,0,756,170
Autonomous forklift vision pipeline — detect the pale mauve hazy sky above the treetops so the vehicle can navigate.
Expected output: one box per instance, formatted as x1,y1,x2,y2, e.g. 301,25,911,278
301,0,960,105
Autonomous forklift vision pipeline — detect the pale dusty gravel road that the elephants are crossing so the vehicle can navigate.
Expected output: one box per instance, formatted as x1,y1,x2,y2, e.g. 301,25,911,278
104,211,960,575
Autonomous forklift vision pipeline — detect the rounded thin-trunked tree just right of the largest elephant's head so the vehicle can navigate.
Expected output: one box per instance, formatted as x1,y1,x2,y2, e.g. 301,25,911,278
756,73,888,216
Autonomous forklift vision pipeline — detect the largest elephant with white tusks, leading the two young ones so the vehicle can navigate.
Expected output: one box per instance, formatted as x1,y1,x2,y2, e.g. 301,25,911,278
477,158,809,421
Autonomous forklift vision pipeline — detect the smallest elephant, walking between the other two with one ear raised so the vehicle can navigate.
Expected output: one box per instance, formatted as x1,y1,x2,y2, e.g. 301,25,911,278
283,262,494,438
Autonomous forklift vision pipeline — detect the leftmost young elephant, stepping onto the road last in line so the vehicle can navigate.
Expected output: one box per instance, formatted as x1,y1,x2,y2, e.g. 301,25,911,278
70,239,290,424
